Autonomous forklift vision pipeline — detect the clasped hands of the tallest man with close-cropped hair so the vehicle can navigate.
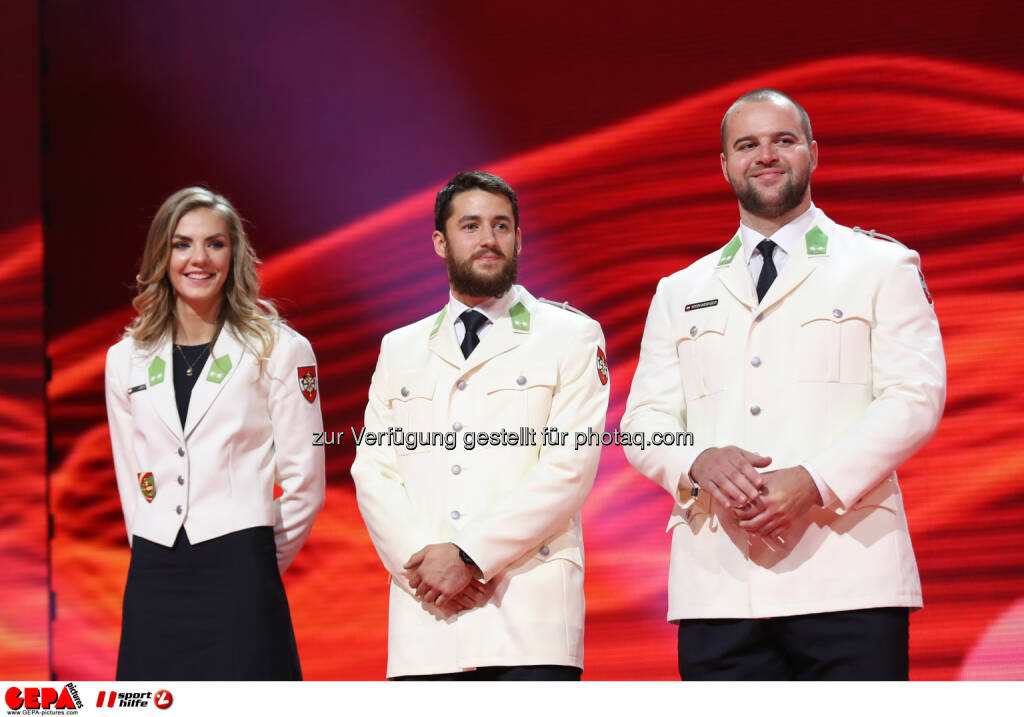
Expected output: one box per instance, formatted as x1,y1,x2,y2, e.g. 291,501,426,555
690,446,821,538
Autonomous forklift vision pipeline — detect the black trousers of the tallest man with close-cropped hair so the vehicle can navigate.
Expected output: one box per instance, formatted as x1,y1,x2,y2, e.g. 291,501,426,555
679,607,909,680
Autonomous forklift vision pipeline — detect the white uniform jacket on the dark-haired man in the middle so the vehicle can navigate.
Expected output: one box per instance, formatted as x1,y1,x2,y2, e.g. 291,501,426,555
352,287,608,677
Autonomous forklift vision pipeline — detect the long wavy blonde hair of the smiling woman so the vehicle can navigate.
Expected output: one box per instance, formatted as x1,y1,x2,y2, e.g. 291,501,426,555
126,186,282,364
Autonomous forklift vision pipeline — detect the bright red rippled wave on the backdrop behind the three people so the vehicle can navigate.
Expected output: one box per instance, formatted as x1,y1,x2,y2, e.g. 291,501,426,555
39,53,1024,679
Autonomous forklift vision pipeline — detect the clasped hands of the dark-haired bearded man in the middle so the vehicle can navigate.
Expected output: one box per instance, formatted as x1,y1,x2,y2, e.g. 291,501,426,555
402,543,487,615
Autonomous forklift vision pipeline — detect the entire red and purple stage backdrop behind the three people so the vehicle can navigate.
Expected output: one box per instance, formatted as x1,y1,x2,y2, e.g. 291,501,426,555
8,0,1024,680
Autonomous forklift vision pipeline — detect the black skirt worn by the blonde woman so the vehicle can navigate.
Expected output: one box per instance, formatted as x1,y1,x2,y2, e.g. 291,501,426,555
117,526,302,680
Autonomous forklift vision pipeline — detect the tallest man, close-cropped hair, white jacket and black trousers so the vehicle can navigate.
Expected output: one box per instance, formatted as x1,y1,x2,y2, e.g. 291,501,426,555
622,89,945,680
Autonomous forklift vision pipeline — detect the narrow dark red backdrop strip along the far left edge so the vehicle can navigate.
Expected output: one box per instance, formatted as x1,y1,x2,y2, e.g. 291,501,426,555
0,1,50,680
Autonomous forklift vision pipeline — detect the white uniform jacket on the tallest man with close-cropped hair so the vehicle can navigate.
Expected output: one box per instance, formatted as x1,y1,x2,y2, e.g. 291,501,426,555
622,210,945,620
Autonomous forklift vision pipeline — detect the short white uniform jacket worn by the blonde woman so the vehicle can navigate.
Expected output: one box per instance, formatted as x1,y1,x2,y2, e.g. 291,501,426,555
106,325,324,573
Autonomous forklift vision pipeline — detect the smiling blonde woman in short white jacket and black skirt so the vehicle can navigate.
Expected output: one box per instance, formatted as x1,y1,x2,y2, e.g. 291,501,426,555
106,187,324,680
